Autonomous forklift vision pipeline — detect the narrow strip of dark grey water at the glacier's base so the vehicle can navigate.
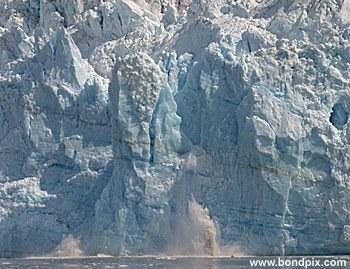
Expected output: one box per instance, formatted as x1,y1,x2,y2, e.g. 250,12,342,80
0,257,350,269
